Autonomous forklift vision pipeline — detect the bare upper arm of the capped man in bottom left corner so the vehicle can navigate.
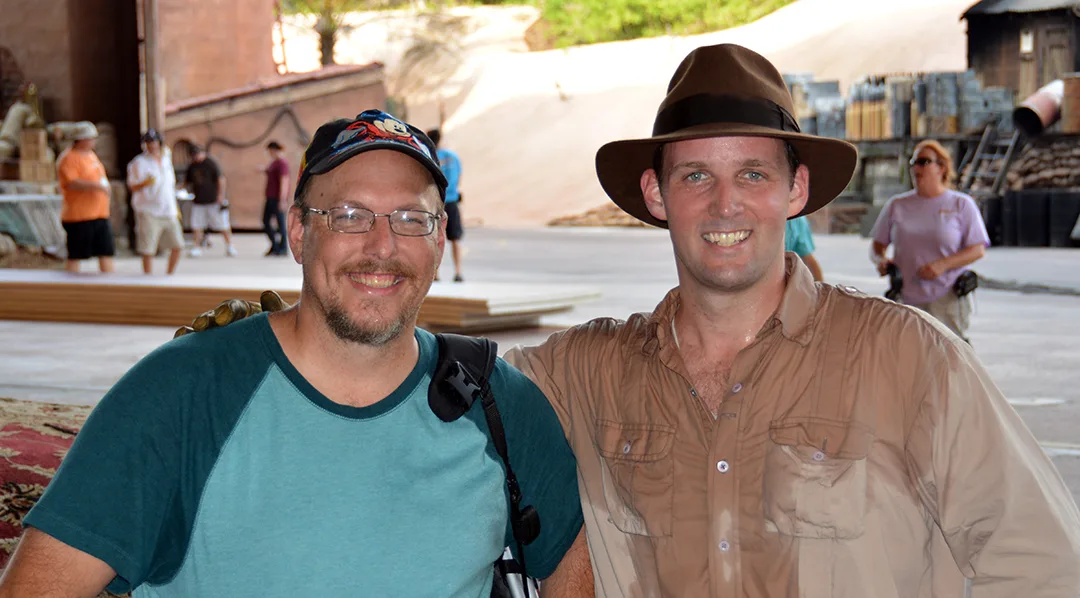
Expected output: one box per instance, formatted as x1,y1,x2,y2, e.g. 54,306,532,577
0,528,117,598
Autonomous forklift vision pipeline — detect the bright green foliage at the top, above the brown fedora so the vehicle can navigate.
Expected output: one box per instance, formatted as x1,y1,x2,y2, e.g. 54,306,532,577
539,0,792,47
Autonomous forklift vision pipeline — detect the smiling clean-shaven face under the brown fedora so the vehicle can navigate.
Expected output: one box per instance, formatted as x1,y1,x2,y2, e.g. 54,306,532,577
642,137,809,293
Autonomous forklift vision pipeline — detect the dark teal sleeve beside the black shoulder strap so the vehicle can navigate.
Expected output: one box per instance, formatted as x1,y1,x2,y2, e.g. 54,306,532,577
491,358,583,580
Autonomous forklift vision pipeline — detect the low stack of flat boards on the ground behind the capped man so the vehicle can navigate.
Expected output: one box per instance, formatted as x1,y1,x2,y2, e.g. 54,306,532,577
0,270,599,331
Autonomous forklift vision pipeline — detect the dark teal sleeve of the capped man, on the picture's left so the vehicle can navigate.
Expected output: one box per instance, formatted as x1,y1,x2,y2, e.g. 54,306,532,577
25,353,179,593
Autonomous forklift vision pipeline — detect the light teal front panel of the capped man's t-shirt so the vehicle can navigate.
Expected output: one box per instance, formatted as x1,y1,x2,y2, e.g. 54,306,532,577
134,366,508,598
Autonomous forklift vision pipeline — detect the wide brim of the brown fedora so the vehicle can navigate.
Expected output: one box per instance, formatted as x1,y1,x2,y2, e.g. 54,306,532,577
596,123,859,229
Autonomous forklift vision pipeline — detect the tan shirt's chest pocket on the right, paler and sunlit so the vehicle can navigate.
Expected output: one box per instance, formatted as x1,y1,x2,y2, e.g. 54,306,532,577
764,421,874,540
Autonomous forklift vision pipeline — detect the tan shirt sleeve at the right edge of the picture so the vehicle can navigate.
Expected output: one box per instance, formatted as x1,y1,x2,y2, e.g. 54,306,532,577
907,337,1080,598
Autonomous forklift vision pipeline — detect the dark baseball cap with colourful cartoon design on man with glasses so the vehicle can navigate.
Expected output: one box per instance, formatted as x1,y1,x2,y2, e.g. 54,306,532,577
294,110,446,201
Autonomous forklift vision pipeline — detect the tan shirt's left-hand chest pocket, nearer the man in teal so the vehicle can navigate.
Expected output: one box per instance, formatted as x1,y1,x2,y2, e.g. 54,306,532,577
596,420,675,536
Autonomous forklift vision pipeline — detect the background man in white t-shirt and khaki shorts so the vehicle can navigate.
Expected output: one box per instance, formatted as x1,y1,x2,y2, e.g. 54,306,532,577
127,128,184,274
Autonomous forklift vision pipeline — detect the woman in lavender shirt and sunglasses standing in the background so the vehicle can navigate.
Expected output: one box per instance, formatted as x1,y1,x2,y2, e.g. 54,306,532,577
870,139,990,340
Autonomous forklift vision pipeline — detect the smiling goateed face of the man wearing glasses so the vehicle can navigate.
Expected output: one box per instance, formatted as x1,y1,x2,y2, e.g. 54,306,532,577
288,150,446,345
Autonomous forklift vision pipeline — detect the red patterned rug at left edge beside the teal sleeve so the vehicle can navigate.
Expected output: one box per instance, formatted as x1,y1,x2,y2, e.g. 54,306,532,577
0,397,123,597
